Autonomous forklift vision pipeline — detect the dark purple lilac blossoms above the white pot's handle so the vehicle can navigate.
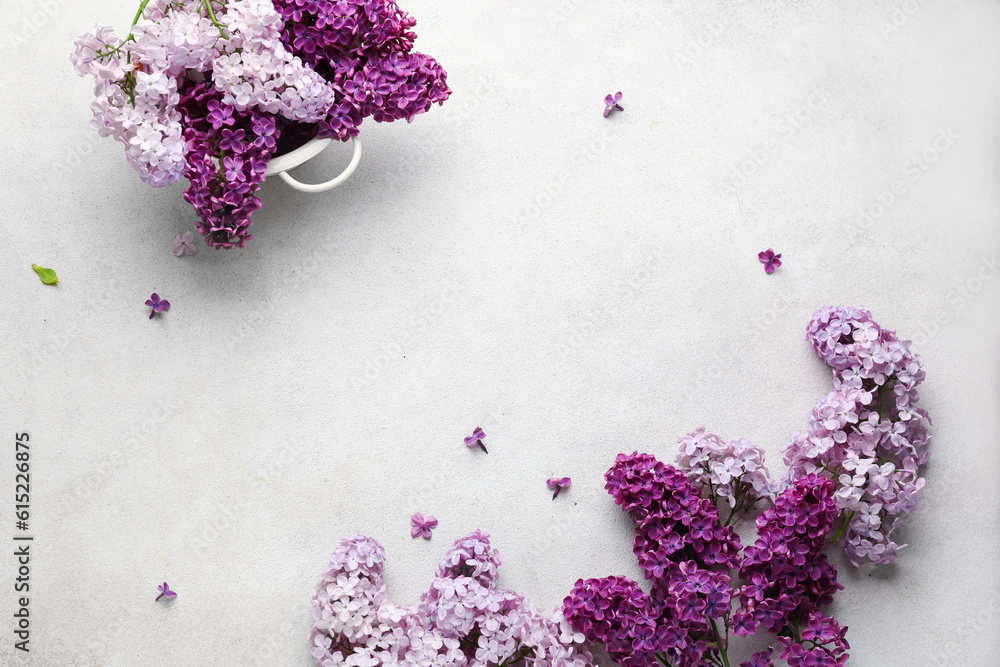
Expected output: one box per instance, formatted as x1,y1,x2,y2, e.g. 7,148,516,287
274,0,451,141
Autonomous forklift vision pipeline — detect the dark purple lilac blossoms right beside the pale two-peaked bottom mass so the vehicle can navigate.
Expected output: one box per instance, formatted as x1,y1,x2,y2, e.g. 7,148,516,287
563,453,740,667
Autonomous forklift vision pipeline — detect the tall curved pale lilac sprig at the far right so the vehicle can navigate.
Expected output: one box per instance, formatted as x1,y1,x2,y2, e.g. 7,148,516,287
785,307,930,565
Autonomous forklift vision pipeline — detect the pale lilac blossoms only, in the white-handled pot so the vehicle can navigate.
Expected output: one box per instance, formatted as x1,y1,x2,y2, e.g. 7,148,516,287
72,0,334,187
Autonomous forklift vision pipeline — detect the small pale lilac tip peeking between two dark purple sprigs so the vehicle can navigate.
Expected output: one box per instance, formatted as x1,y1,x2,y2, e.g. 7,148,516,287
676,426,778,524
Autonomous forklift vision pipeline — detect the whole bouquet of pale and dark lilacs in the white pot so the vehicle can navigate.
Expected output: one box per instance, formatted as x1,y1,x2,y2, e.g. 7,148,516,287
72,0,451,248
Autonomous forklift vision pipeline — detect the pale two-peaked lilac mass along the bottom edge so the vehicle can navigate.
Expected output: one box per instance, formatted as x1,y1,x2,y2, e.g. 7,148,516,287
309,531,593,667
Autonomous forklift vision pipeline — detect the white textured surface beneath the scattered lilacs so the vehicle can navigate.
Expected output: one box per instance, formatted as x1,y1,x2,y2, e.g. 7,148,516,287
0,0,1000,667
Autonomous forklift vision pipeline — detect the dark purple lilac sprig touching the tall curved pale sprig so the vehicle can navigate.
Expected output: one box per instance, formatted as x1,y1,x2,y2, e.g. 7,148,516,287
733,475,850,667
